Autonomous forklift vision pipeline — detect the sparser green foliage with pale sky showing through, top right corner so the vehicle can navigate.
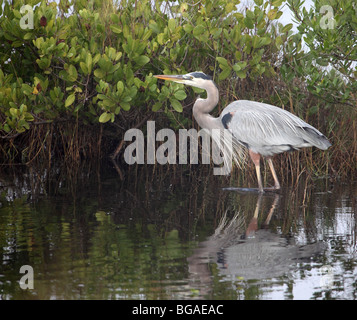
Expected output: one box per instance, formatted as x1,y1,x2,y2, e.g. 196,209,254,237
284,0,357,107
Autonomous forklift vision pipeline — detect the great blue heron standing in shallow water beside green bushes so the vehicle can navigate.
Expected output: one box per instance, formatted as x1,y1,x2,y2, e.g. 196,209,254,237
154,72,331,193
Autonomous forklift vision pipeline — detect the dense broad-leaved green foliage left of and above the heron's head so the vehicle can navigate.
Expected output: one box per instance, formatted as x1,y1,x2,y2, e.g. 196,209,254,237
0,0,283,137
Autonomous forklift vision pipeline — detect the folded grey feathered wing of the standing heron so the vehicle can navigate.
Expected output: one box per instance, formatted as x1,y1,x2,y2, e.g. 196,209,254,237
221,100,330,156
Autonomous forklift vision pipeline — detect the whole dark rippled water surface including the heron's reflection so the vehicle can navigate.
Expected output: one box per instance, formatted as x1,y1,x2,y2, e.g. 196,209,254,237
0,167,357,300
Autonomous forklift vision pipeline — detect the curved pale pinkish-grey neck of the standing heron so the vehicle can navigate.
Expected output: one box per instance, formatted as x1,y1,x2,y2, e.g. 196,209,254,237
192,82,223,129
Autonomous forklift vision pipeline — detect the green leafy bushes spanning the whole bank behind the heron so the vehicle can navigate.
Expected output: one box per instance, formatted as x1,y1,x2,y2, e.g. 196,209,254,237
0,0,356,176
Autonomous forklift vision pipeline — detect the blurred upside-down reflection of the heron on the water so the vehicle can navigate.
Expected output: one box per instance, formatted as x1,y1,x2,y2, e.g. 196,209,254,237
188,188,326,297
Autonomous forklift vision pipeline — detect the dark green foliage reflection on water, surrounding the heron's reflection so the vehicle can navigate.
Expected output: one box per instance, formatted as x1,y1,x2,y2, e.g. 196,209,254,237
0,171,355,299
